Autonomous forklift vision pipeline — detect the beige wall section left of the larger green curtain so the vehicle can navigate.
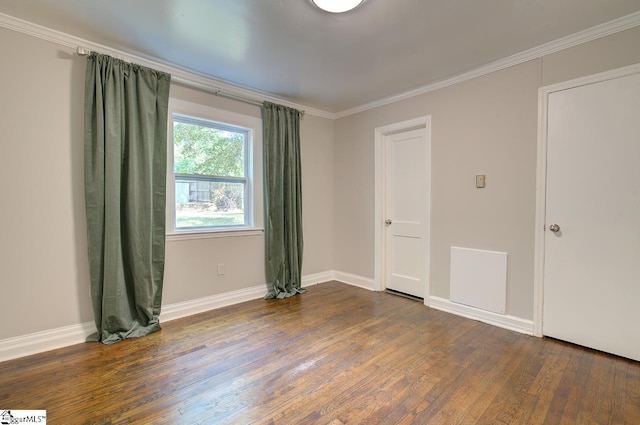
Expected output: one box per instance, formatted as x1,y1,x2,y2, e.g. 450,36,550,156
0,28,92,339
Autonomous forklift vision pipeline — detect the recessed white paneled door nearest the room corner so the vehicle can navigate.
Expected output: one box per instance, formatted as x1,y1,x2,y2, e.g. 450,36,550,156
384,129,427,298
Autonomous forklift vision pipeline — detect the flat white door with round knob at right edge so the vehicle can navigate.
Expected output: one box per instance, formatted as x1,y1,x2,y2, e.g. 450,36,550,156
542,70,640,360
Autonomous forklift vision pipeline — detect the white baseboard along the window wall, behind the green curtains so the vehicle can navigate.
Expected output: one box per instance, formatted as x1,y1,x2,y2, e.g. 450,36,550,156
0,271,333,362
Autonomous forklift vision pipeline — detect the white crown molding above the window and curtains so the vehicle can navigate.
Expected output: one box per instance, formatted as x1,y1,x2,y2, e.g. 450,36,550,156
0,13,335,119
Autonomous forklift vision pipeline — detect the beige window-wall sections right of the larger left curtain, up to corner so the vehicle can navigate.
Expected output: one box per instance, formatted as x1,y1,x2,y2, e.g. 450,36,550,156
163,85,333,304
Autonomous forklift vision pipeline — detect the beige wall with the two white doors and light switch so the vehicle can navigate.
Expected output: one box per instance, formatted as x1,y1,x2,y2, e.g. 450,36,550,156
334,28,640,319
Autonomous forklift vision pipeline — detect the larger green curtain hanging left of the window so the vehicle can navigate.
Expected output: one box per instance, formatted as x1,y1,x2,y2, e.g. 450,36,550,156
84,53,171,344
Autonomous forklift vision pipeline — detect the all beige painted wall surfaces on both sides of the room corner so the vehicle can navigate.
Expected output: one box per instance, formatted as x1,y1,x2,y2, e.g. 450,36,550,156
0,19,640,339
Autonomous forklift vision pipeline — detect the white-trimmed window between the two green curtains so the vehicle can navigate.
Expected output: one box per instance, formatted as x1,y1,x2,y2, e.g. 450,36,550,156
167,100,262,235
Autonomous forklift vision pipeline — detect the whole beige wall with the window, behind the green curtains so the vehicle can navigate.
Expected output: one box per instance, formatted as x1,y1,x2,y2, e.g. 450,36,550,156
0,28,334,341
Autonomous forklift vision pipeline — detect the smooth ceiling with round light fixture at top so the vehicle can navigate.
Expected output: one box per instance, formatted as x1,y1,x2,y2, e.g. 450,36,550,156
0,0,640,113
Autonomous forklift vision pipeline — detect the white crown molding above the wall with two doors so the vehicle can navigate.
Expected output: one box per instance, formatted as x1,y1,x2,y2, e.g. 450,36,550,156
334,12,640,119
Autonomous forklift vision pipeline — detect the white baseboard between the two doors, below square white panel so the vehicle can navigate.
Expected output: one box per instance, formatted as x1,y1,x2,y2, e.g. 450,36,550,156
429,296,533,335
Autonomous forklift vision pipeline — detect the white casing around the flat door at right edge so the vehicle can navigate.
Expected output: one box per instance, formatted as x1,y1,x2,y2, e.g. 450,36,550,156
533,64,640,337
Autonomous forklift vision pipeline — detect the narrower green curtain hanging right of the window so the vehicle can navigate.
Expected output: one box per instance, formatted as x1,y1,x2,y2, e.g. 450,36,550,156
262,102,305,298
